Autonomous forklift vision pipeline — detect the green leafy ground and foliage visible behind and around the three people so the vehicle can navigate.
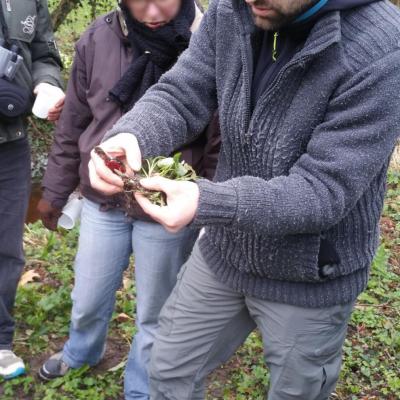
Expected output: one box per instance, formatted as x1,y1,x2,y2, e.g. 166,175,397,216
0,0,400,400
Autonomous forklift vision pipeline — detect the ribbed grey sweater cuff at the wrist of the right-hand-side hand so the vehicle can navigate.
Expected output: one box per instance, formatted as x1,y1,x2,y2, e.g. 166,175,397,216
193,179,238,226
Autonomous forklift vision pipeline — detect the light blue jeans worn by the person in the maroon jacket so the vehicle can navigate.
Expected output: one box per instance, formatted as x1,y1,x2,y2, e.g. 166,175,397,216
63,199,197,400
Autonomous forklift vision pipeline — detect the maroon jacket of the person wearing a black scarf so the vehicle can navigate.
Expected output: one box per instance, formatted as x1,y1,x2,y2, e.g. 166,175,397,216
42,11,219,212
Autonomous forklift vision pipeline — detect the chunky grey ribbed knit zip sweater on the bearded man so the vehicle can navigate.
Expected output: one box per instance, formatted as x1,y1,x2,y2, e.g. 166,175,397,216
106,0,400,307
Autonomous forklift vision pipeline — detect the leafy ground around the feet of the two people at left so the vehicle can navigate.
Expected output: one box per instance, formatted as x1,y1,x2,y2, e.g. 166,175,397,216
0,223,135,400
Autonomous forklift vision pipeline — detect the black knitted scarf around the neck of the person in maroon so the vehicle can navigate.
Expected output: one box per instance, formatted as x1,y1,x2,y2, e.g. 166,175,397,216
110,0,196,112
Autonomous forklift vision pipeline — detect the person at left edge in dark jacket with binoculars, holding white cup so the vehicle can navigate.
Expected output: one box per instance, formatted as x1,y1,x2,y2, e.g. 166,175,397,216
0,0,63,378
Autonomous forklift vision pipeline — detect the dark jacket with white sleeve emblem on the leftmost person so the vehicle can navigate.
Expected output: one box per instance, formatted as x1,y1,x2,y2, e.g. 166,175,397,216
0,0,62,145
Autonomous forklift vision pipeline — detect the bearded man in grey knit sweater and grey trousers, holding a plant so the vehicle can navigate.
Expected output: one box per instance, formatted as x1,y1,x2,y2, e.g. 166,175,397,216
90,0,400,400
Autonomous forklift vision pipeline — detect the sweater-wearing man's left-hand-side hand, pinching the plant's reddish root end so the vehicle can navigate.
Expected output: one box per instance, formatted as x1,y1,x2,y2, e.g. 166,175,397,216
89,133,142,195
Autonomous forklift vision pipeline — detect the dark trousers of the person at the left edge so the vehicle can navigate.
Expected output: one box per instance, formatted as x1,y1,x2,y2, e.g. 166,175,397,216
0,139,31,350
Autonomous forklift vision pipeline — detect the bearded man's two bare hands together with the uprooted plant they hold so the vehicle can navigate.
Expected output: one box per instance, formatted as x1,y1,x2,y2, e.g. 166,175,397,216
89,133,199,232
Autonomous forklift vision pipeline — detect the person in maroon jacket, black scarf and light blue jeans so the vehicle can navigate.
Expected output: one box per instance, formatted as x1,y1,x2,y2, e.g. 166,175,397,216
38,0,219,399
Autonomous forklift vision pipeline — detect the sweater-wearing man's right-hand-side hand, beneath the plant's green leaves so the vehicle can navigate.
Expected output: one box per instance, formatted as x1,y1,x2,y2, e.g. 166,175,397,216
135,176,200,232
